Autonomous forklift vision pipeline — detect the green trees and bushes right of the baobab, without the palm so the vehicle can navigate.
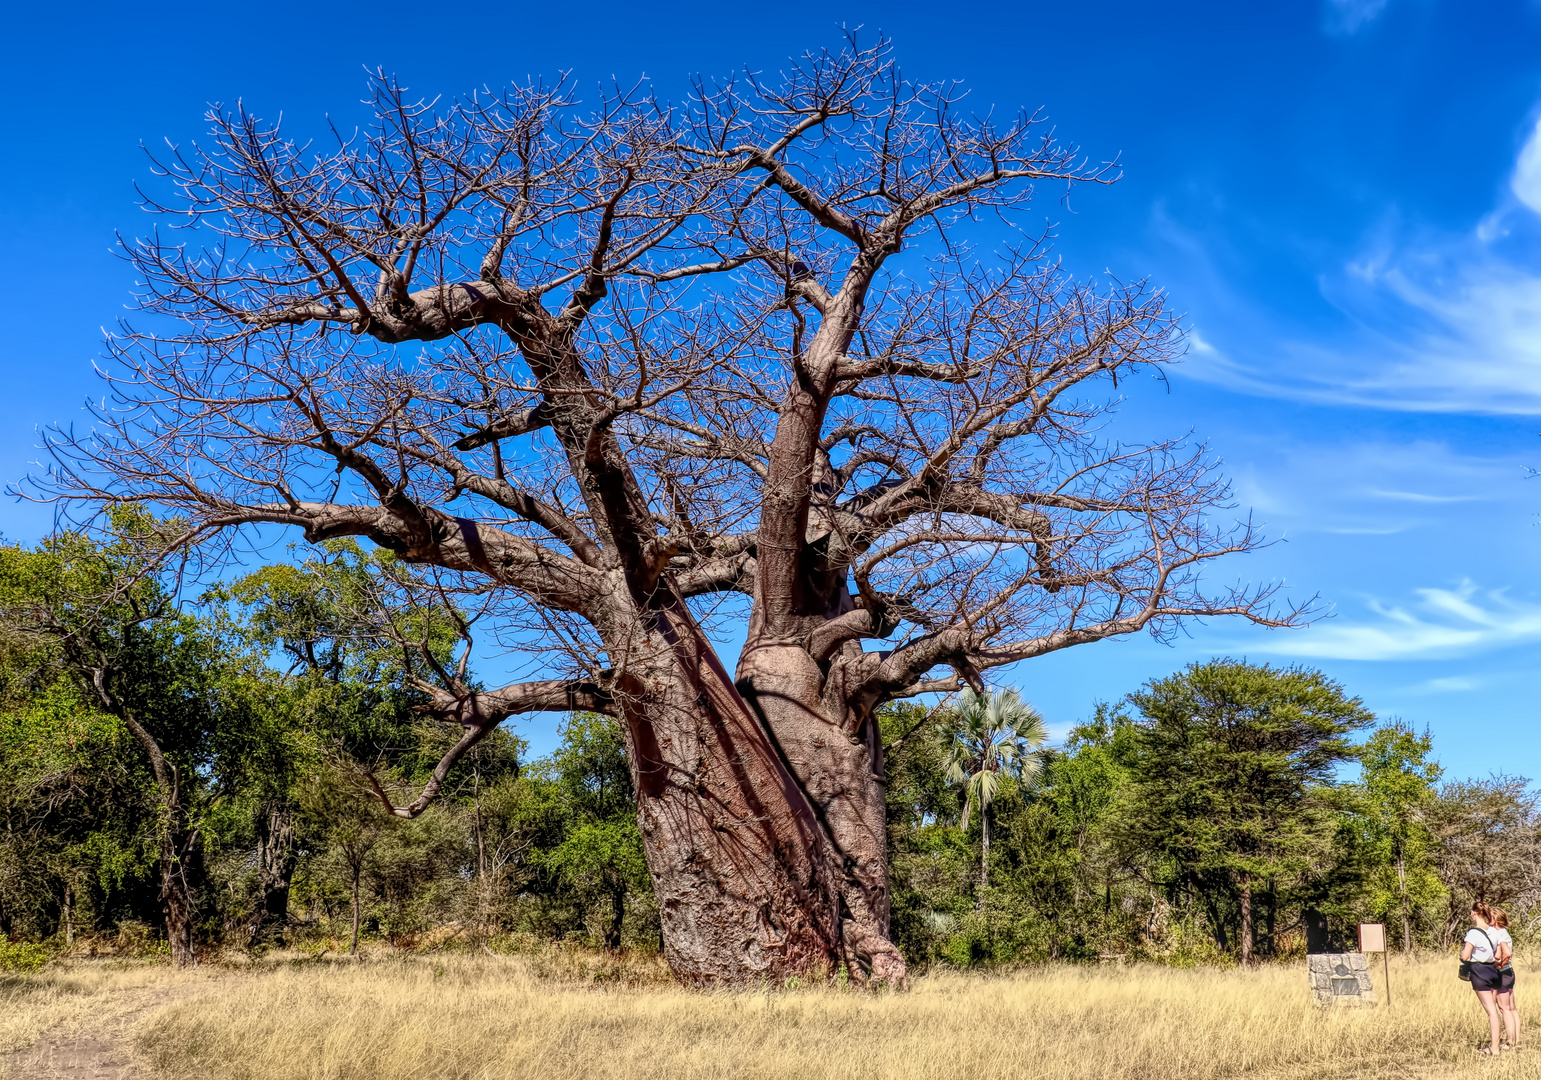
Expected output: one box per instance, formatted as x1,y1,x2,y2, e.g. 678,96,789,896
883,659,1541,964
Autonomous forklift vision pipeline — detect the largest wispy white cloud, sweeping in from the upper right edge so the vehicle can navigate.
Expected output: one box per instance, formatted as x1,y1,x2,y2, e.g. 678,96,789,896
1168,109,1541,414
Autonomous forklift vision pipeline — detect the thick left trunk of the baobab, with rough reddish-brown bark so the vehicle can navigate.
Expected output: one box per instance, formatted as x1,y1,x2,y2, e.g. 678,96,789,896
616,601,840,986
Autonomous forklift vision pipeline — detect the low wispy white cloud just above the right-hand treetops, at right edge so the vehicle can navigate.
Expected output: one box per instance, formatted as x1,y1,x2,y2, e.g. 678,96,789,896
1248,581,1541,662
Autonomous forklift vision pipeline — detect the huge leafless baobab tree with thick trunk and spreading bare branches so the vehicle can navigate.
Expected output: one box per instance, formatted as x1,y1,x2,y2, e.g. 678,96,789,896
30,42,1291,983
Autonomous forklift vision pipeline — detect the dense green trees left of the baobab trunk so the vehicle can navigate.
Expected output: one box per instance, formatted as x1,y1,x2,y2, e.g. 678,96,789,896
0,511,658,963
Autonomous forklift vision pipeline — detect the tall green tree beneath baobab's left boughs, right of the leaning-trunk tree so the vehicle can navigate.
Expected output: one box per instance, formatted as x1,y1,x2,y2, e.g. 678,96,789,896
206,539,471,943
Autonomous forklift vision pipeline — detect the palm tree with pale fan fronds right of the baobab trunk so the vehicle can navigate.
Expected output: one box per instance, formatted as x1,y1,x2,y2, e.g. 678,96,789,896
945,690,1048,904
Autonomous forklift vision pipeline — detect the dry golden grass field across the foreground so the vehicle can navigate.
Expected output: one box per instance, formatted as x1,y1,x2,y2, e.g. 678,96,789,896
0,954,1541,1080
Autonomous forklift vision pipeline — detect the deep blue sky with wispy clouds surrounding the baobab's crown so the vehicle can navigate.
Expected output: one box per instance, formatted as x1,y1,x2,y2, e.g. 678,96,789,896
0,0,1541,778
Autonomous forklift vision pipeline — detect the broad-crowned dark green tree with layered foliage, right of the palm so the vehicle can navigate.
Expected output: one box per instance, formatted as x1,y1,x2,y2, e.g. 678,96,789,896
1122,659,1375,964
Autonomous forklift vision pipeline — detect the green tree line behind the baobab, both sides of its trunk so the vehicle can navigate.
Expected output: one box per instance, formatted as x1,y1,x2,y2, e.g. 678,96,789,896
0,510,1541,968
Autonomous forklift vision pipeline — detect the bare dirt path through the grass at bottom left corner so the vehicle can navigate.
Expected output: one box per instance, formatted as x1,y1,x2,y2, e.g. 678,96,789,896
0,984,205,1080
